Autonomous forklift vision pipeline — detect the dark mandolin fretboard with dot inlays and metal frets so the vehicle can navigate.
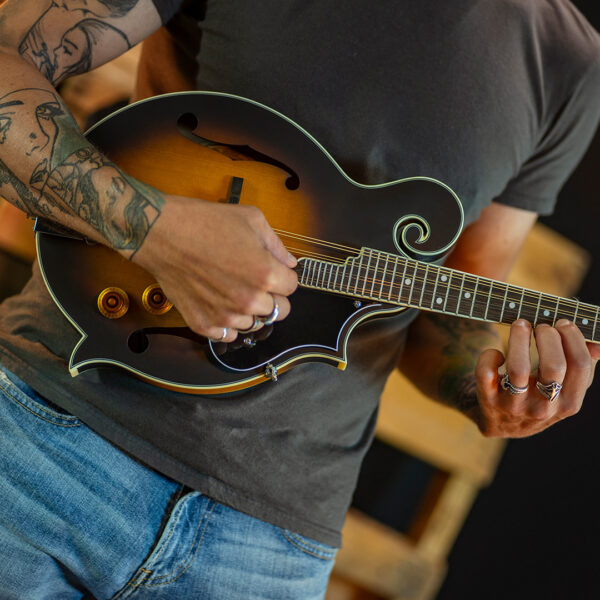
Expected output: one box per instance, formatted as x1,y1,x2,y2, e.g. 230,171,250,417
297,248,600,343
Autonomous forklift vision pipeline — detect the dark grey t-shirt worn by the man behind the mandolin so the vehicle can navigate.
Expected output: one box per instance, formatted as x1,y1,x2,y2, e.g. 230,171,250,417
0,0,600,545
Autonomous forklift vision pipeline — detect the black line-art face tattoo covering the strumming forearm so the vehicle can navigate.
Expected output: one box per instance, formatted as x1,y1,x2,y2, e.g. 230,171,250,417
0,89,164,257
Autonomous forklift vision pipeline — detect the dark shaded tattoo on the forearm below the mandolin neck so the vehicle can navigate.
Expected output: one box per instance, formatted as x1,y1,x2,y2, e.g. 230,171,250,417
426,313,499,412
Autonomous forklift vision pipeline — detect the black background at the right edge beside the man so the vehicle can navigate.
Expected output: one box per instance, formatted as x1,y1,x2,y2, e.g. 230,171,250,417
438,0,600,600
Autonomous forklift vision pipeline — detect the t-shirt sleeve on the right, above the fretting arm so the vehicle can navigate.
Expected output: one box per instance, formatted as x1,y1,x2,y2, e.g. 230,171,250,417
495,56,600,215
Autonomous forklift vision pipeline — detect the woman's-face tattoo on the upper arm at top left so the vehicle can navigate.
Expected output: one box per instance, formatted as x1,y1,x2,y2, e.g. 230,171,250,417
19,0,139,85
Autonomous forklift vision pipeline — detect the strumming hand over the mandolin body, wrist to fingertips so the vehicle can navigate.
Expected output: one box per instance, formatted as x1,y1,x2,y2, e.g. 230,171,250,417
132,196,298,341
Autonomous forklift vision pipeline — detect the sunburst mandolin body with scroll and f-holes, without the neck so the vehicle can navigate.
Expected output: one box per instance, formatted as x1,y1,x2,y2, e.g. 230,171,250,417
37,92,463,395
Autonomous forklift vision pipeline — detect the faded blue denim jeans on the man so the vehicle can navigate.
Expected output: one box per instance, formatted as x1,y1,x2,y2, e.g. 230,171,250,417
0,370,336,600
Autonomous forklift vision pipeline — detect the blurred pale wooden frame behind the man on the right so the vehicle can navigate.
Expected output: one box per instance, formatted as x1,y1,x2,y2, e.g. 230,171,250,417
326,224,589,600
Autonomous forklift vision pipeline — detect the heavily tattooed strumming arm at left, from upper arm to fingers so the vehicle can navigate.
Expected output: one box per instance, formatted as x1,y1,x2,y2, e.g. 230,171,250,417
0,0,297,341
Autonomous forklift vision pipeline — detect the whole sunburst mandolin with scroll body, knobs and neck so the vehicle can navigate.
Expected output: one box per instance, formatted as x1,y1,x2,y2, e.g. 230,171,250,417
36,92,600,396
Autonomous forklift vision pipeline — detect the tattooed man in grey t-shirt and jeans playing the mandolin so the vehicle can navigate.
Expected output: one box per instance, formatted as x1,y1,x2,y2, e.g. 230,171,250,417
0,0,600,599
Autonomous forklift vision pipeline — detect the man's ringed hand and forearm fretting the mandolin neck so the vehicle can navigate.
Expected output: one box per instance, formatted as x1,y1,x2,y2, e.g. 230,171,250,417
400,204,600,437
